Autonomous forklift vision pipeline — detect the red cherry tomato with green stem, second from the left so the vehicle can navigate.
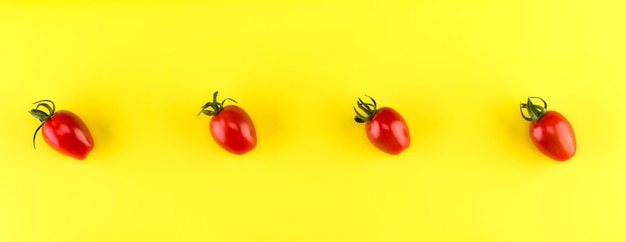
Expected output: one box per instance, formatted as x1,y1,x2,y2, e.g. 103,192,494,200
198,92,257,155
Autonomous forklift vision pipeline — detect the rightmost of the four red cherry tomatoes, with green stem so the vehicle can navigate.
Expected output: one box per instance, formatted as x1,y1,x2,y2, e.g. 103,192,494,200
520,97,576,161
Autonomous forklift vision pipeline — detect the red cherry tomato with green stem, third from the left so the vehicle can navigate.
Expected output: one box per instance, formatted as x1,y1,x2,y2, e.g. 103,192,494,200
353,95,411,155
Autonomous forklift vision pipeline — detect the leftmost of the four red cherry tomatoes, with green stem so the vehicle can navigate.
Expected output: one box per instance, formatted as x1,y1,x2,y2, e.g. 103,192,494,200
29,100,94,160
